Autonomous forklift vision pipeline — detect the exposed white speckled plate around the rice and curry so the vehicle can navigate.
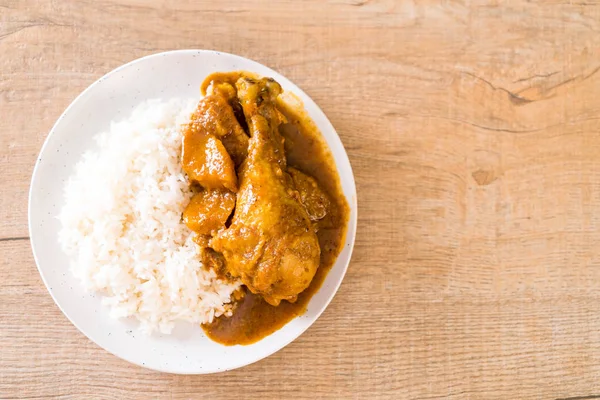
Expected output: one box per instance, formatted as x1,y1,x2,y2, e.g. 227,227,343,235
29,50,357,374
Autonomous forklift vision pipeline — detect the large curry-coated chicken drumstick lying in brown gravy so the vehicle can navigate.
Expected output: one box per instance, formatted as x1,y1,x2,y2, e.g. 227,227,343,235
210,77,321,305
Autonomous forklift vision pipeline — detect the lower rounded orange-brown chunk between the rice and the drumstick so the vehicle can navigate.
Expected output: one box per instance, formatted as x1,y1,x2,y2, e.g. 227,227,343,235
183,189,235,235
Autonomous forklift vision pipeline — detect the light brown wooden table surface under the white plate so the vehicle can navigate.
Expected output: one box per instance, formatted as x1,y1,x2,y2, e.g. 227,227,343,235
0,0,600,400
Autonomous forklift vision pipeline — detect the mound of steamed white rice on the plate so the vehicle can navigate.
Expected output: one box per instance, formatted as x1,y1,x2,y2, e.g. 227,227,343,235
59,99,239,333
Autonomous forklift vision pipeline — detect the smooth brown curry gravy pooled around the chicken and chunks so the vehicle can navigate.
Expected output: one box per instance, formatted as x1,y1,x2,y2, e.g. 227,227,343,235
201,72,350,346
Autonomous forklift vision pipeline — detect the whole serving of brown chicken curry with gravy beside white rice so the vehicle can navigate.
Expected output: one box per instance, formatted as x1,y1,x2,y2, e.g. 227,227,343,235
182,72,349,345
